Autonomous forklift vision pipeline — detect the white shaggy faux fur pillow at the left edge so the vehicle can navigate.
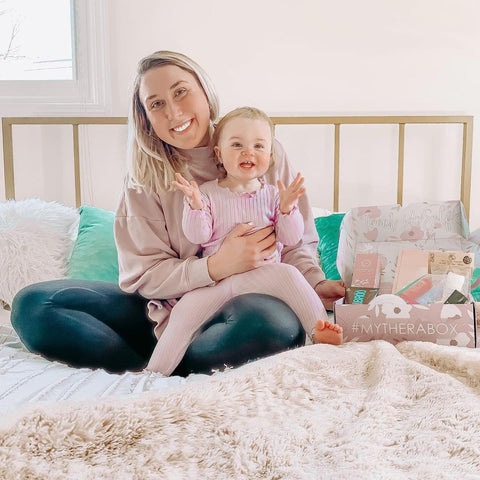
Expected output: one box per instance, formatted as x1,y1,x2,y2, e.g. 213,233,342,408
0,199,79,305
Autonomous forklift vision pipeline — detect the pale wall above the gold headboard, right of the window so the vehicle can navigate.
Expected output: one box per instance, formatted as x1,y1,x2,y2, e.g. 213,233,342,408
0,0,480,228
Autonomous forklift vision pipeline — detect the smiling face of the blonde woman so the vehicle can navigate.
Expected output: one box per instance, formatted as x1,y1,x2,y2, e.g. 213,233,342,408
139,65,210,148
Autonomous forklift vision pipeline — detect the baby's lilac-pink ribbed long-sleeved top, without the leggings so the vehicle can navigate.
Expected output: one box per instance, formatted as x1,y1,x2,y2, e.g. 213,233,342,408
182,179,304,262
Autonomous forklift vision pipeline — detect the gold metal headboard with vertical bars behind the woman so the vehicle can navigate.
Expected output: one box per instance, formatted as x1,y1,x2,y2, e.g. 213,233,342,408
2,115,473,218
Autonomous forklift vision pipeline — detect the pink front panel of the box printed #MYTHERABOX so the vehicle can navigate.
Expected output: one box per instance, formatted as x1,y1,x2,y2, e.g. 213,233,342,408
334,294,476,348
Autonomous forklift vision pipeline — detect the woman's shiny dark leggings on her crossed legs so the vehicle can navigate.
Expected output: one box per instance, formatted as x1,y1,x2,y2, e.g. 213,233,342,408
11,280,305,375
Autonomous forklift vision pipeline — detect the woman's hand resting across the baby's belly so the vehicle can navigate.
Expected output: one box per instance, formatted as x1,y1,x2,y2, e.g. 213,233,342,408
207,223,277,281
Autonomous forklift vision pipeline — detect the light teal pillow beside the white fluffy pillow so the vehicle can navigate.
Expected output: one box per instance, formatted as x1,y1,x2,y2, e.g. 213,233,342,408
67,205,118,283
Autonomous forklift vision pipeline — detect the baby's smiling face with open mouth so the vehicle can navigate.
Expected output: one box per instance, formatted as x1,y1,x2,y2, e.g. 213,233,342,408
215,117,272,182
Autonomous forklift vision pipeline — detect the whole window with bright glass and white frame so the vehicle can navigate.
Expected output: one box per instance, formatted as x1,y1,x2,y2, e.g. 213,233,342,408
0,0,108,115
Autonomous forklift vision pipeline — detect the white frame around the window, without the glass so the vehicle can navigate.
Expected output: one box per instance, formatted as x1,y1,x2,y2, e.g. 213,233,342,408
0,0,110,116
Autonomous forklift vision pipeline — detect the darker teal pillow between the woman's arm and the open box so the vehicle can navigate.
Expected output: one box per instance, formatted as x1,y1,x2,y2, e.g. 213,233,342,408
315,213,345,280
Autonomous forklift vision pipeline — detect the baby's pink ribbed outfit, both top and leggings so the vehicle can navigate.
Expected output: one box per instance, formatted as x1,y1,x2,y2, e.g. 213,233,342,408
147,180,327,375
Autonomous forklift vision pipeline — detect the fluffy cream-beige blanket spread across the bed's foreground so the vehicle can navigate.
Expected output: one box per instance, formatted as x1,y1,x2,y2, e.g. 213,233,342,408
0,341,480,480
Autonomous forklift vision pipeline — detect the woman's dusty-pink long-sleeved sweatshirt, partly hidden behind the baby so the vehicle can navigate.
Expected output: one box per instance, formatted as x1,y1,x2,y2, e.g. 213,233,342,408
114,141,325,337
